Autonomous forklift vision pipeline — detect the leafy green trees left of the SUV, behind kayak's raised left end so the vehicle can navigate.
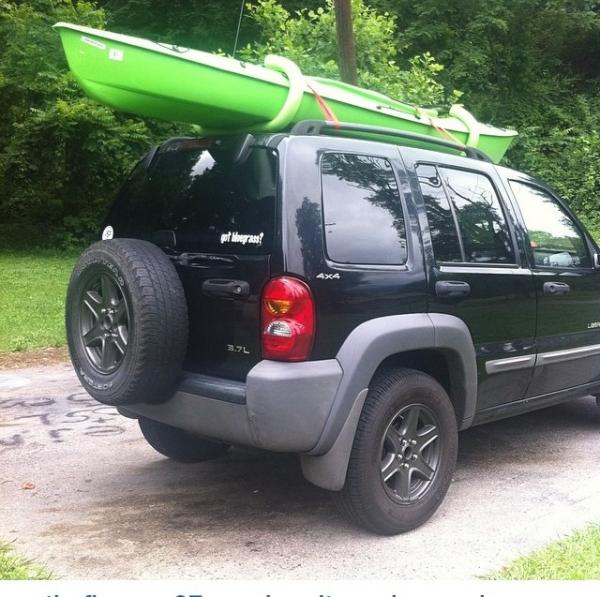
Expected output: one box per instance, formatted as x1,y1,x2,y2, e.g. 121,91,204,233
0,0,172,246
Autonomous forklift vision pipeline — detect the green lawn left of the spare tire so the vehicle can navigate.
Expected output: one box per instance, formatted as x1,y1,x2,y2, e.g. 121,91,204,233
0,250,76,352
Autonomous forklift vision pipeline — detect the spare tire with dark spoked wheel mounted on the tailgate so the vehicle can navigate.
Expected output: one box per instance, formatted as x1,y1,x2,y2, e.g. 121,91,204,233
66,238,188,406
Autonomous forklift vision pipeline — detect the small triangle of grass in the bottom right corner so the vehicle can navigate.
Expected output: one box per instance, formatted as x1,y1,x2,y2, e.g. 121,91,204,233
491,525,600,580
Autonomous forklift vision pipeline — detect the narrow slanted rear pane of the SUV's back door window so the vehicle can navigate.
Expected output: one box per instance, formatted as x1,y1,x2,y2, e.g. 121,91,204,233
417,164,463,262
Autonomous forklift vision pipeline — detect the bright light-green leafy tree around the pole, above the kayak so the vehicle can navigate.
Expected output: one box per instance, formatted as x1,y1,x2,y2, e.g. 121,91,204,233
240,0,454,103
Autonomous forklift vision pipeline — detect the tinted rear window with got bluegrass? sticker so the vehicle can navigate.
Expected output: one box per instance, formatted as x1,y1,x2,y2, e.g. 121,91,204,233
106,140,277,254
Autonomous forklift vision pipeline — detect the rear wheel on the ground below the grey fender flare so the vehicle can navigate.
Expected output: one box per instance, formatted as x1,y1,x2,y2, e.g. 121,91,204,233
336,369,458,535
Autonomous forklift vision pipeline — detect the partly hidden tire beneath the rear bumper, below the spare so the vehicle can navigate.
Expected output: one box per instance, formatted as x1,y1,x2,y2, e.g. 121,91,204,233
138,417,229,463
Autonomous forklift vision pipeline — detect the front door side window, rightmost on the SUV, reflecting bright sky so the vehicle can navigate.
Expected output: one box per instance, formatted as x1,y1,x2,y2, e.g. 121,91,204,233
510,180,591,268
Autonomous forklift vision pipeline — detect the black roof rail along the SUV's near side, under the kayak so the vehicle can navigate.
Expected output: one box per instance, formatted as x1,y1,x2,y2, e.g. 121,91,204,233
290,120,493,163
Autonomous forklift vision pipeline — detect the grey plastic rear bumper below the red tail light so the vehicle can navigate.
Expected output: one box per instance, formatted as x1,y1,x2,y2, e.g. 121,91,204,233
119,359,343,453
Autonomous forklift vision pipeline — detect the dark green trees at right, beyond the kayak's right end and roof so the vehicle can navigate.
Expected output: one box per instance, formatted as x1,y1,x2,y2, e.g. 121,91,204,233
371,0,600,233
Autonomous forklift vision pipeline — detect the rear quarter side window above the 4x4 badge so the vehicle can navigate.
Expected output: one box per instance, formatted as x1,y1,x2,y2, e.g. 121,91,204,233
321,153,407,265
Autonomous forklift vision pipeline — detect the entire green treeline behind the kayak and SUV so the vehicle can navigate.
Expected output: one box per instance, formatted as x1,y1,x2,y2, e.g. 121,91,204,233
0,0,600,243
